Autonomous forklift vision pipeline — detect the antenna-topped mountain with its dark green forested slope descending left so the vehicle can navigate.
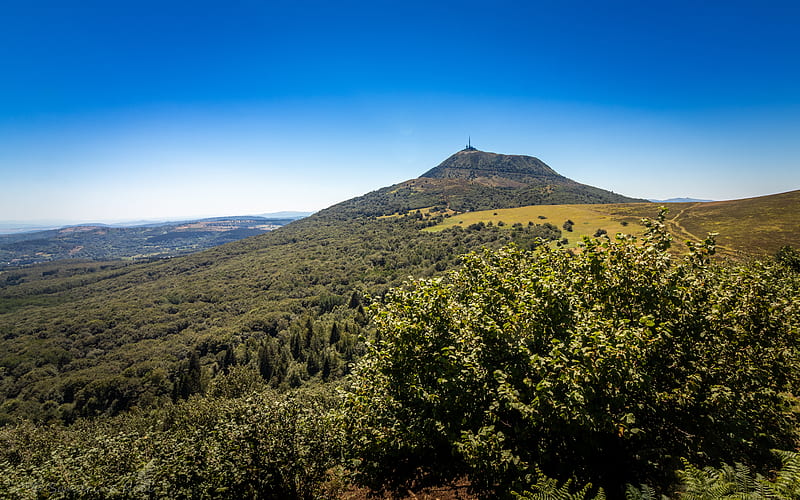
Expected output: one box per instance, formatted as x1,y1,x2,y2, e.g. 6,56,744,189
0,147,644,422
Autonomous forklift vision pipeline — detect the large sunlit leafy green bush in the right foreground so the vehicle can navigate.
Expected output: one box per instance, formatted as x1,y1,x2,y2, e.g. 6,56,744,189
346,214,800,497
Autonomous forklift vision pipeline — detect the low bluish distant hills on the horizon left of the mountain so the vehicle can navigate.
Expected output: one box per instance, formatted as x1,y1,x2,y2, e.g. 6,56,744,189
0,216,299,269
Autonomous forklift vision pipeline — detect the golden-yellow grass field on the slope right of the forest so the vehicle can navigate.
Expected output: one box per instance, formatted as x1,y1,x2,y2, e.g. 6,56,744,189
427,190,800,258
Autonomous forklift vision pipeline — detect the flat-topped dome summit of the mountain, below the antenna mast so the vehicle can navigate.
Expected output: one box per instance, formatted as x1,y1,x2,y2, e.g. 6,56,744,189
420,148,569,185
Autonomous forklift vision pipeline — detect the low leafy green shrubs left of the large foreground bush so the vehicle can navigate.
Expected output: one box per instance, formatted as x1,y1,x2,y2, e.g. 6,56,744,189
0,382,341,499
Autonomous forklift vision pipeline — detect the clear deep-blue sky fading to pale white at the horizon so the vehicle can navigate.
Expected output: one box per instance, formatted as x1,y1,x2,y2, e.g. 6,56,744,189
0,0,800,221
